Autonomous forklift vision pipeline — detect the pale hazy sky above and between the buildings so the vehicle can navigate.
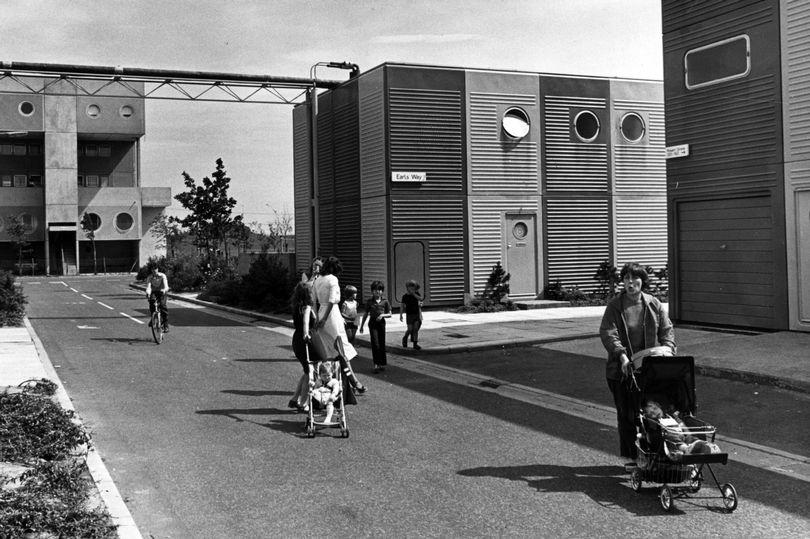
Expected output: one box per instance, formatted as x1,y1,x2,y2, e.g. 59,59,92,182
0,0,663,230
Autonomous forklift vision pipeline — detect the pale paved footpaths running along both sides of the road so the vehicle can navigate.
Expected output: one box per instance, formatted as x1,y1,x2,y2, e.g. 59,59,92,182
0,284,810,537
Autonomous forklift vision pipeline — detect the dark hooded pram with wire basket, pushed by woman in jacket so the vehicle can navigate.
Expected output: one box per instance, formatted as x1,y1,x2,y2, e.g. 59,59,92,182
630,356,737,512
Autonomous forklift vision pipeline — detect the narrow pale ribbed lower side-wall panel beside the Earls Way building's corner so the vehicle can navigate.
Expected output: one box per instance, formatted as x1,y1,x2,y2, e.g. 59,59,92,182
360,196,392,298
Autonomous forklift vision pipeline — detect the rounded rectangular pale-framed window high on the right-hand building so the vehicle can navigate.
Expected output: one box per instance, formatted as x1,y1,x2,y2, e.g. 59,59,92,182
683,34,751,90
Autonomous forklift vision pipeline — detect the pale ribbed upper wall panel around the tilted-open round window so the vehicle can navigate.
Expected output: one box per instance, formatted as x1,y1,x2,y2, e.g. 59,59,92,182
469,92,538,195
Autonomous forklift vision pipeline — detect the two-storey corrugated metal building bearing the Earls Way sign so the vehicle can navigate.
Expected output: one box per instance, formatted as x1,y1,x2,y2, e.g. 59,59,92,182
293,63,667,305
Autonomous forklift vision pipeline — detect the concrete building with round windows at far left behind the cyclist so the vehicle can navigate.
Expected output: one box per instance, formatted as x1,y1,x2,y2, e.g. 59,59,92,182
0,78,171,275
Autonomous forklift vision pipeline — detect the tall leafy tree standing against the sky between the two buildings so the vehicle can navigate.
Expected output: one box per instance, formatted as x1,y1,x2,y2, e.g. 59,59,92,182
171,158,241,264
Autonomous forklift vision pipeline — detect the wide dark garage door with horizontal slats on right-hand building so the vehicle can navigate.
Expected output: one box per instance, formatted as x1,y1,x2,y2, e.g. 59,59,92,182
676,196,775,328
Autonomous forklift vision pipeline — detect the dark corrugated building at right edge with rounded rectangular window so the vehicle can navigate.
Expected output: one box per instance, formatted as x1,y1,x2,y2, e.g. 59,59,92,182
662,0,810,331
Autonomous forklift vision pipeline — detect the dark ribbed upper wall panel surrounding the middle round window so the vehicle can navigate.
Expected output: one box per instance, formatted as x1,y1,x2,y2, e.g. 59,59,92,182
544,95,608,192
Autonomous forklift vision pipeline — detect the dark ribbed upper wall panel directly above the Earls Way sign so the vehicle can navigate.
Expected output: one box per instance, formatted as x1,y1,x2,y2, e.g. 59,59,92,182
388,88,465,191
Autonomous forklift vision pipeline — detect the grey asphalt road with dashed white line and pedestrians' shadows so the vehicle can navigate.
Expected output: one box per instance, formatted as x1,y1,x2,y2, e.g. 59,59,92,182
25,277,810,538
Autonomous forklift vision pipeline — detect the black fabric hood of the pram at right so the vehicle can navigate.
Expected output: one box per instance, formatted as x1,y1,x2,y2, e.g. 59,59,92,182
635,356,697,415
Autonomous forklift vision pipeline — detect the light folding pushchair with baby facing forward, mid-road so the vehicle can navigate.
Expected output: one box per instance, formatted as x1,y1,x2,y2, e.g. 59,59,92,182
305,361,349,438
